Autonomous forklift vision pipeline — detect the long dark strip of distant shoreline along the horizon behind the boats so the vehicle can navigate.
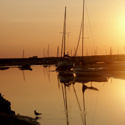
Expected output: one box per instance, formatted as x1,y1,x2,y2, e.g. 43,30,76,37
0,55,125,66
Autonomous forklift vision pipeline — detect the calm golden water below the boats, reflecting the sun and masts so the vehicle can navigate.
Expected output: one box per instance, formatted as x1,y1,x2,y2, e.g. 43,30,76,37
0,66,125,125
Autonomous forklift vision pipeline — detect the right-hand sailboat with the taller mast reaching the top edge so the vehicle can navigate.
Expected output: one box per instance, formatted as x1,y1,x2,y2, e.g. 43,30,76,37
73,0,102,77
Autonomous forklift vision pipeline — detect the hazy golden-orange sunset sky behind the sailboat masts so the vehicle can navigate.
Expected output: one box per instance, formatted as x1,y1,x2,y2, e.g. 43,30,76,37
0,0,125,58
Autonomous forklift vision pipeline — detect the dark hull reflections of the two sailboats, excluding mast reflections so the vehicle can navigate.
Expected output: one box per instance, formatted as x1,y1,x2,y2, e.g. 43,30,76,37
58,71,108,85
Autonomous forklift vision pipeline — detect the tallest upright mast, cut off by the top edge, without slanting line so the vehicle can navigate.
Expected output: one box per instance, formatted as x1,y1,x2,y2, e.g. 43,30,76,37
82,0,85,56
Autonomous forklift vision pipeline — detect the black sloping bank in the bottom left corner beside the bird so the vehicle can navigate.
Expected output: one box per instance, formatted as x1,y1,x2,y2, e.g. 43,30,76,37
0,94,40,125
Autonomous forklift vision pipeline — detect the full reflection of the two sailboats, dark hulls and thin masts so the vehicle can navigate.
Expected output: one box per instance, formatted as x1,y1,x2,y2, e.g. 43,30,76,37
58,72,99,125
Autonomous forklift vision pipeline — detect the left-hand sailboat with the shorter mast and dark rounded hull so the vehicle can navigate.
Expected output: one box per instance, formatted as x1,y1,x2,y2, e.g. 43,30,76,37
56,6,73,71
